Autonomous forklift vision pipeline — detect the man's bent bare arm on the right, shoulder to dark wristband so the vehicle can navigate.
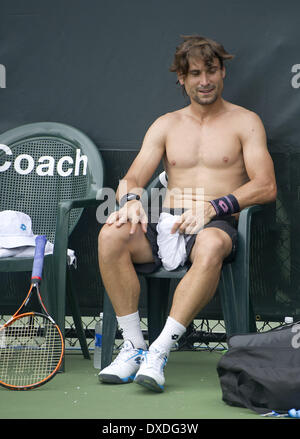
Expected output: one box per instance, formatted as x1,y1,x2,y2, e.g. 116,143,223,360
232,112,277,210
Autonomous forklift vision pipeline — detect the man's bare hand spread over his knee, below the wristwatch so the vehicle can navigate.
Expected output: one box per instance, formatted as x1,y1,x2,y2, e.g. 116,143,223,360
106,200,148,235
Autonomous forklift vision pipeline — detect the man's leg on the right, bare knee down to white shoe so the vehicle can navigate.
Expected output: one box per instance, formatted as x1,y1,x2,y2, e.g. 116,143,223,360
135,228,232,392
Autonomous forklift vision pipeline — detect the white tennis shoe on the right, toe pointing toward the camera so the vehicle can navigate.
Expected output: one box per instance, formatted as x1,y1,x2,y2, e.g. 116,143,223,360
134,347,168,392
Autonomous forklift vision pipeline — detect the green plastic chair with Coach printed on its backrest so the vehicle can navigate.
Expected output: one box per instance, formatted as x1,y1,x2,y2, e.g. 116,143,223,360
0,122,104,364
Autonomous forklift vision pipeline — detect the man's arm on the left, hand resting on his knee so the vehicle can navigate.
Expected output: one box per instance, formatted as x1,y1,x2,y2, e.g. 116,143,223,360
107,115,169,233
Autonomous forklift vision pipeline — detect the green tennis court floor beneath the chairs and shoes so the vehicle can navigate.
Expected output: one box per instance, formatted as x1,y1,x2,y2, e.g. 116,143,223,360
0,351,264,420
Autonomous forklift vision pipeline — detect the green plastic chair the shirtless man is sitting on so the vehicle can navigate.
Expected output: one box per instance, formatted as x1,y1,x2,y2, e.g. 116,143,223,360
101,177,263,368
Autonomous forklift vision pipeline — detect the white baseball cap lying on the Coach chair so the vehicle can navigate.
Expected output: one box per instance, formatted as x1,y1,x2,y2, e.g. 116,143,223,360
0,210,36,248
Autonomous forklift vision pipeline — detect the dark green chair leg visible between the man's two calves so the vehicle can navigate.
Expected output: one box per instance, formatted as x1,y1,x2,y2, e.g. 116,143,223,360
146,277,170,345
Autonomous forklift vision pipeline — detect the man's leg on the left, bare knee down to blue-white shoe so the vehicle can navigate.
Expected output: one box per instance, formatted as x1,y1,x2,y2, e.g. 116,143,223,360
99,223,153,383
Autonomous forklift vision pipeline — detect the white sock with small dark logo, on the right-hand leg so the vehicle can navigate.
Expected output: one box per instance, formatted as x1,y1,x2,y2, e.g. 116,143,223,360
149,316,186,355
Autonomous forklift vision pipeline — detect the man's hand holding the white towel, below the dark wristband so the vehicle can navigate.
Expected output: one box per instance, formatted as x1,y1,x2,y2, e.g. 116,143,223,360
171,201,216,235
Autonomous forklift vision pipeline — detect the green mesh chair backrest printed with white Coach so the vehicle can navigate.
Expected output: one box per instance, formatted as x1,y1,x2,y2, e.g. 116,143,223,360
0,122,104,242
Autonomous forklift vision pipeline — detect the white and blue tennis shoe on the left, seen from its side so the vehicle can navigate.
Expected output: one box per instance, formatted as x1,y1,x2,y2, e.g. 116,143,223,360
98,340,146,384
